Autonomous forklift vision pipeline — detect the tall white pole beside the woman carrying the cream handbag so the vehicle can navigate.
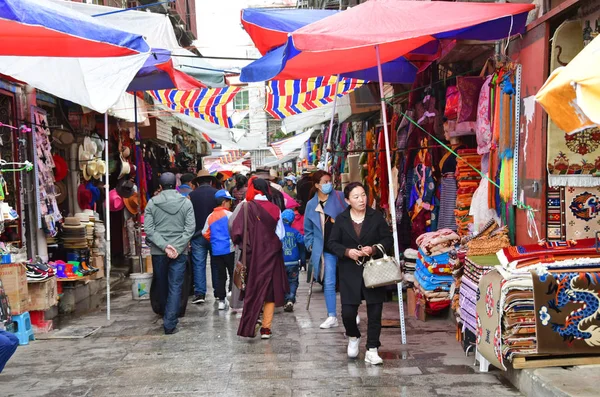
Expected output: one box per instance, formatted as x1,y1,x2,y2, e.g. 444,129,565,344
375,45,406,345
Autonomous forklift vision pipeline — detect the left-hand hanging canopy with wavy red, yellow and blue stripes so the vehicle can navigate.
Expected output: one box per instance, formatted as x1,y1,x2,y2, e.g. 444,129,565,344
149,87,240,128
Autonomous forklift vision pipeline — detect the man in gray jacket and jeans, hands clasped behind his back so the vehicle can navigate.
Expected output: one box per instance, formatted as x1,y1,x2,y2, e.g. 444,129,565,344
144,172,196,335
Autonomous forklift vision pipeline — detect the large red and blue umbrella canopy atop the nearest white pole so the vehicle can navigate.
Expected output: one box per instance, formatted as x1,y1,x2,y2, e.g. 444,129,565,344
240,0,534,82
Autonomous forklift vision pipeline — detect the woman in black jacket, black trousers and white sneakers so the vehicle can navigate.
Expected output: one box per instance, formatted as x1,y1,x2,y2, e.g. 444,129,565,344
327,182,394,364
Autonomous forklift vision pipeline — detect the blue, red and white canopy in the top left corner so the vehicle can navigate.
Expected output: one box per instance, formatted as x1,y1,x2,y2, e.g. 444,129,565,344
0,0,150,113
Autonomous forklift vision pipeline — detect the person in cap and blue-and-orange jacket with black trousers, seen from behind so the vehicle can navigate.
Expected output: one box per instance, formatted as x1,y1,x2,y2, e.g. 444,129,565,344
202,189,235,310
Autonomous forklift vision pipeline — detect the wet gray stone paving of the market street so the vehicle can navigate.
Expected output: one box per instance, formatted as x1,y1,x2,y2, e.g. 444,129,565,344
0,276,520,397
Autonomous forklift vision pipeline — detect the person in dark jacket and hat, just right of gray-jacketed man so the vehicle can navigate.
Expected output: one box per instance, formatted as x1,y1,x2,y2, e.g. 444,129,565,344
189,170,218,303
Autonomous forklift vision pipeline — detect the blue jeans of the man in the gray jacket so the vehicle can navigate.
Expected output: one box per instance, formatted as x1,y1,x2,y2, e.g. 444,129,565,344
152,255,187,331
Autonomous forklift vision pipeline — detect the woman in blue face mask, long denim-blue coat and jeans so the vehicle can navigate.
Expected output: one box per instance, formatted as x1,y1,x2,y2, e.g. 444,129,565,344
304,171,348,329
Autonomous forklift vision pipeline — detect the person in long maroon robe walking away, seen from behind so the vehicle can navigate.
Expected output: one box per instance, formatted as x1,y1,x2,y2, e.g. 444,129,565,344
231,178,289,339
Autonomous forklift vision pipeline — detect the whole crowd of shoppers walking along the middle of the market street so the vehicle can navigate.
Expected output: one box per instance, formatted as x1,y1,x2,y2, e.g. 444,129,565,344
145,169,393,364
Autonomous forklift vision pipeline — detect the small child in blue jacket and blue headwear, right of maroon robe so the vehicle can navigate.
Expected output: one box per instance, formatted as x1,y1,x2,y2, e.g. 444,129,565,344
281,209,304,312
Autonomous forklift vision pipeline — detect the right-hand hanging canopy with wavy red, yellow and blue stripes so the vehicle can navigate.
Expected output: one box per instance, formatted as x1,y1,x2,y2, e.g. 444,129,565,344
265,76,365,119
